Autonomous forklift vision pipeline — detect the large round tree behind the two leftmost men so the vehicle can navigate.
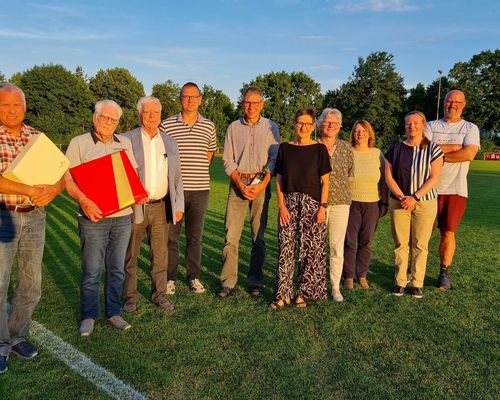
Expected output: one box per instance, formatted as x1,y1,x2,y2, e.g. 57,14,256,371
15,64,94,143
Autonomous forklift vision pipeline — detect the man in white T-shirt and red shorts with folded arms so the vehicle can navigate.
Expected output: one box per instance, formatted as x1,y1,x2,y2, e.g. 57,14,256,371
424,90,480,291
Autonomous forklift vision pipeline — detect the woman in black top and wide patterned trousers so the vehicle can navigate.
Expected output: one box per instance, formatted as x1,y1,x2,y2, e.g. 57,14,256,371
271,108,331,308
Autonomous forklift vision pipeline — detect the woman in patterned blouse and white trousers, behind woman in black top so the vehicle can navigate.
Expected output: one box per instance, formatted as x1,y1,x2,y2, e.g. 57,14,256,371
318,108,354,301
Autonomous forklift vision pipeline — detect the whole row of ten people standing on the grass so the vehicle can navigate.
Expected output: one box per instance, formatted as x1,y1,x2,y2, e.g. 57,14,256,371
0,82,479,373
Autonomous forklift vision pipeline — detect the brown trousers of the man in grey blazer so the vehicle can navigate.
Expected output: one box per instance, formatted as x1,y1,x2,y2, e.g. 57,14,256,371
123,202,169,304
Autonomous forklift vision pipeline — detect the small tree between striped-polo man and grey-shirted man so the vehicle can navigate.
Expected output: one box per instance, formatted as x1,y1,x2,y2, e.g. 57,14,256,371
200,85,237,147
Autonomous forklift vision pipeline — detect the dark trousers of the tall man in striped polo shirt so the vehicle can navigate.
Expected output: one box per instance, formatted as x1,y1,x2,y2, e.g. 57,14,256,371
168,190,210,281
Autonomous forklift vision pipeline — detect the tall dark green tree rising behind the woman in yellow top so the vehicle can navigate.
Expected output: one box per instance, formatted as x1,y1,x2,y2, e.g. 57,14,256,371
323,52,406,150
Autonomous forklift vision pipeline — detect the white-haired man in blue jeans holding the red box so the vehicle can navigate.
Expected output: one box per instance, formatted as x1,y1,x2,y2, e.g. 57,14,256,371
65,100,137,336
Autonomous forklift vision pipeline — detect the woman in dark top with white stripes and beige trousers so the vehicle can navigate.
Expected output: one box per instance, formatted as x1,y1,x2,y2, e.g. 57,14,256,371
385,111,443,299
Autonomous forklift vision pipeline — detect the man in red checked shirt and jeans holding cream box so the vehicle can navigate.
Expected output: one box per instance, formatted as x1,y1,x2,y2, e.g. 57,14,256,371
0,83,64,373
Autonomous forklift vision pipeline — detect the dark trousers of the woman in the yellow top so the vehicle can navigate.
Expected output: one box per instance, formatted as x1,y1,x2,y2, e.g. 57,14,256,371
344,201,379,279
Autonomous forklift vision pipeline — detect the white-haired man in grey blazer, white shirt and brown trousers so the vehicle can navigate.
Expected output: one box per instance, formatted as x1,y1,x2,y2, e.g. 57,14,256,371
123,96,184,312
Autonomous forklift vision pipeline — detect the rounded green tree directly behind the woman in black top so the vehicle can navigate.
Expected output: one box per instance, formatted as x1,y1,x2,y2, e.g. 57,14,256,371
240,71,322,140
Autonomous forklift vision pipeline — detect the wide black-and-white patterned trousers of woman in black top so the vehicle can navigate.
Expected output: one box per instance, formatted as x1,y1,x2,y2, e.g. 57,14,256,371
275,192,327,300
